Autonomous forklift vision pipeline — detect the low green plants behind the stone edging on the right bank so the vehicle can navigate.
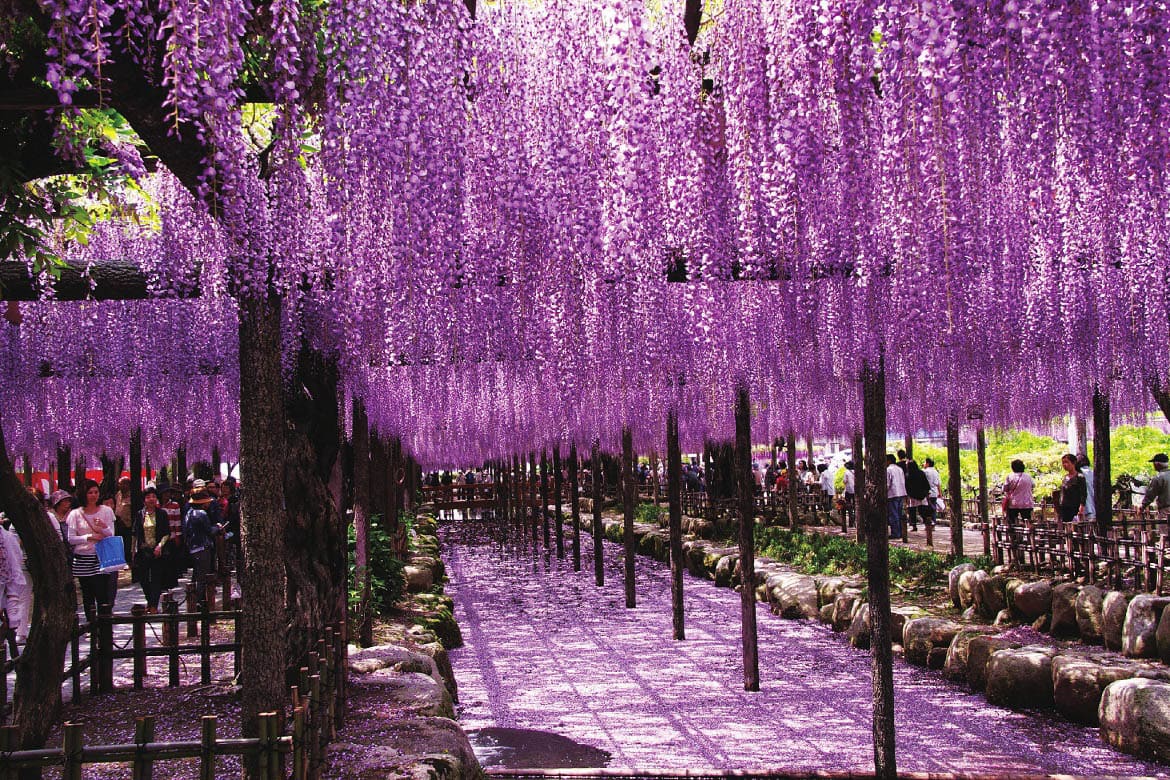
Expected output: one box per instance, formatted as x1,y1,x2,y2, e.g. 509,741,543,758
756,526,992,593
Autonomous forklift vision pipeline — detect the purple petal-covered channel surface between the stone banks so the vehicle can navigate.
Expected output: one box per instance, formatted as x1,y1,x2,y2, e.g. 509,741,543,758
441,518,1165,775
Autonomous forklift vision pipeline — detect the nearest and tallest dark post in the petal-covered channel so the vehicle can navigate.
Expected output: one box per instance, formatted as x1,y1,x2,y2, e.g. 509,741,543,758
859,359,897,778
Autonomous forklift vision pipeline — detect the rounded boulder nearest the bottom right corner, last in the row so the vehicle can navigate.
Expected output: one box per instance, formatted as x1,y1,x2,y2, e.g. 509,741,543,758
1097,678,1170,761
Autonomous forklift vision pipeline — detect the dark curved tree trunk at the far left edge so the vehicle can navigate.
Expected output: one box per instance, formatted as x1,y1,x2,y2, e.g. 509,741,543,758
0,418,77,757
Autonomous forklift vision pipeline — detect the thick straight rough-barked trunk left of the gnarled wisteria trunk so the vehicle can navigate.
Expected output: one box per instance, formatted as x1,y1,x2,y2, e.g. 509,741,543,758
235,295,288,737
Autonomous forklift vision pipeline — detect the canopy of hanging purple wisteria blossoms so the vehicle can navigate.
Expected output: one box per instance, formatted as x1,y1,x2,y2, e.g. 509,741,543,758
0,0,1170,465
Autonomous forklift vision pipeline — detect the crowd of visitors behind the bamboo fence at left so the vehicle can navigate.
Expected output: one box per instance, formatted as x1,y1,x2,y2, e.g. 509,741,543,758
0,477,241,643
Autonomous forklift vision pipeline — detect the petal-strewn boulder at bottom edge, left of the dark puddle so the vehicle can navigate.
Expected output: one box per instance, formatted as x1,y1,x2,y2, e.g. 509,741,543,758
325,718,483,780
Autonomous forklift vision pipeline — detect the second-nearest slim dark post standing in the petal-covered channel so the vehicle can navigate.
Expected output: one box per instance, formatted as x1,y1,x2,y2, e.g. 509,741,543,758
730,386,758,691
